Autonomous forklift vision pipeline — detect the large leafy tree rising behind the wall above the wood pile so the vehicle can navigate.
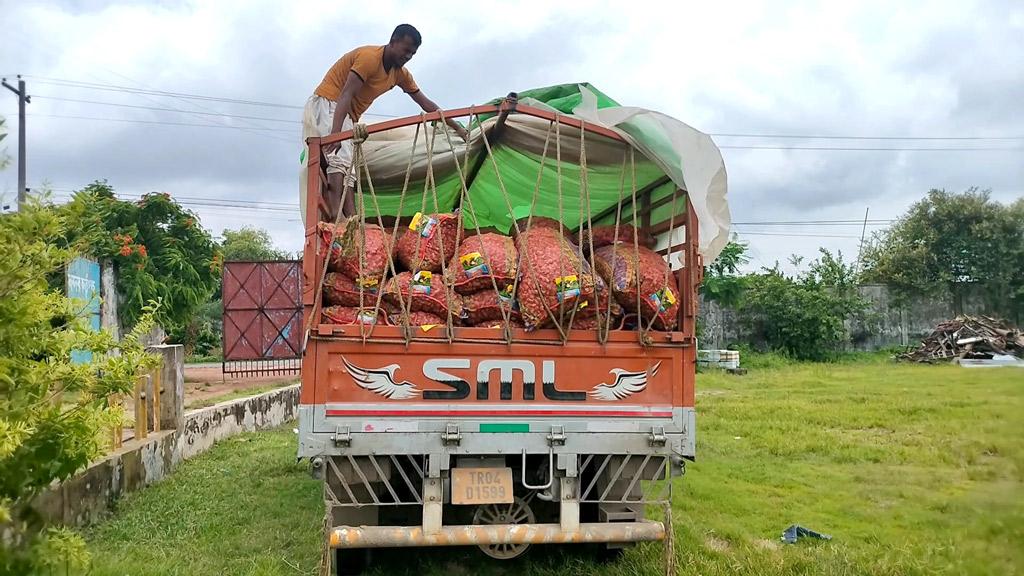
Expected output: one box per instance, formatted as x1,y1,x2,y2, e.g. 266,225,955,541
864,188,1024,314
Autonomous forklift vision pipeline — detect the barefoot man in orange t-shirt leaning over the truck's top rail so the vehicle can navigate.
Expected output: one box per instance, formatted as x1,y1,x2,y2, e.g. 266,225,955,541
299,24,469,219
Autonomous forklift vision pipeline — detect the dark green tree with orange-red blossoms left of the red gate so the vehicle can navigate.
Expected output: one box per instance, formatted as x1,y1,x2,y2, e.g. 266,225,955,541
59,181,223,336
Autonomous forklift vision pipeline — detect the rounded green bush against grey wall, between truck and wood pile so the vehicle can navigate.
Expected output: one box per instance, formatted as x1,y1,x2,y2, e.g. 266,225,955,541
738,248,868,360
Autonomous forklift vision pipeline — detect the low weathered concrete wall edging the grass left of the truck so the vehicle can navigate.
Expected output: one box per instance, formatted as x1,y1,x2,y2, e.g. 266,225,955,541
32,384,299,526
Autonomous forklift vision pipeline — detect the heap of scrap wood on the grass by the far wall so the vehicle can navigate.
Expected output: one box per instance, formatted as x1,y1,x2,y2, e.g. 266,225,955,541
899,316,1024,362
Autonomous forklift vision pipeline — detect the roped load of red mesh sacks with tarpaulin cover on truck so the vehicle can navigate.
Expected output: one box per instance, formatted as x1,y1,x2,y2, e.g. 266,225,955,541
306,85,728,345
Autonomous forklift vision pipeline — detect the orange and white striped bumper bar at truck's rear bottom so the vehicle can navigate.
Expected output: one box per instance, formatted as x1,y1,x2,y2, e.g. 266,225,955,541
330,521,665,548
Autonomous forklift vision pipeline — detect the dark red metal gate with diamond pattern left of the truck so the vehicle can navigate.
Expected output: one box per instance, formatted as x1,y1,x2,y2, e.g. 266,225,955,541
222,260,302,375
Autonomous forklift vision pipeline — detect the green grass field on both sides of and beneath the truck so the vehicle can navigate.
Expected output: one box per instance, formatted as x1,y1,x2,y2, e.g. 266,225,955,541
87,360,1024,576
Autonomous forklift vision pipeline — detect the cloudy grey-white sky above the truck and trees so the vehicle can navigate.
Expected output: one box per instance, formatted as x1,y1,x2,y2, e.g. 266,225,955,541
0,0,1024,265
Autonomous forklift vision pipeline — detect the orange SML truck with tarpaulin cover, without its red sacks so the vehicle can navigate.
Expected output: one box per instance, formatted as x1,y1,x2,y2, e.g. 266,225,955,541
299,84,728,574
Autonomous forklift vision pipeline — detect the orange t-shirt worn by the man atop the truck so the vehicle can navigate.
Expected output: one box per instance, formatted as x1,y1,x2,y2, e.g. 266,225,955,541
313,46,420,120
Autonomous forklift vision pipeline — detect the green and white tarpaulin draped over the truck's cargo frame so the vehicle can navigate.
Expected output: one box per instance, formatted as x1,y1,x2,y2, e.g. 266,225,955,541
299,84,729,258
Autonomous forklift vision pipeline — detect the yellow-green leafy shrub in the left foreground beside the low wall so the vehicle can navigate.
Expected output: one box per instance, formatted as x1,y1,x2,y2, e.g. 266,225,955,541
0,194,157,574
